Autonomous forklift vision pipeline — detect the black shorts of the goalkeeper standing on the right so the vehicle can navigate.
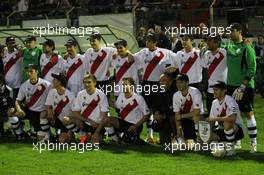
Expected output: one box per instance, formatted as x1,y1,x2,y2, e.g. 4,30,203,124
227,85,254,112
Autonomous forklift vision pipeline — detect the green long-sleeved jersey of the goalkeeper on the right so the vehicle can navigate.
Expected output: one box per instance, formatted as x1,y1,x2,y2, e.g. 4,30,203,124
226,42,256,88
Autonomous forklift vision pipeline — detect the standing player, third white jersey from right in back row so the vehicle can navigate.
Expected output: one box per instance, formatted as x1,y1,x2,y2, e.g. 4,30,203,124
134,33,175,143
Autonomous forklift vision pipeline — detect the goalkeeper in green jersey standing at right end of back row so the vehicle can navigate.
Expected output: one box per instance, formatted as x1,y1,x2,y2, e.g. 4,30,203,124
226,23,257,153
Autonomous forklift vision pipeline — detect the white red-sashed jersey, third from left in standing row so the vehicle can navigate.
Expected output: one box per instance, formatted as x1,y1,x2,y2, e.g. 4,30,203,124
64,54,86,96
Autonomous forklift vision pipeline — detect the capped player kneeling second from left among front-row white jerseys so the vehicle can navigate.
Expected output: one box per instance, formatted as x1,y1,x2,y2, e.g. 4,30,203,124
40,73,79,142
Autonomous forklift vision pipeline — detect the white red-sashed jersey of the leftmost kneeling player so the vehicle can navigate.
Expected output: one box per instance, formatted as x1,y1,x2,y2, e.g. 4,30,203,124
17,78,51,112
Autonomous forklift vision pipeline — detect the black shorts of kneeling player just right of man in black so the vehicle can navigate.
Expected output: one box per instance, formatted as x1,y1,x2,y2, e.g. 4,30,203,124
181,118,197,140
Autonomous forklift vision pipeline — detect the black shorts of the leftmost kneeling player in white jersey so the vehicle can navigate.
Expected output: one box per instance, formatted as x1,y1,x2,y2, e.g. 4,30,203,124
23,108,42,132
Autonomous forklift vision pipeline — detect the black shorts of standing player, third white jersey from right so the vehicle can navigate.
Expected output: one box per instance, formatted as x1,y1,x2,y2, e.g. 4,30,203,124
142,81,159,110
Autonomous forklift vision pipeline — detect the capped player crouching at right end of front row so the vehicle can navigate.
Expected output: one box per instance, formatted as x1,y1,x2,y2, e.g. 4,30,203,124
207,81,244,157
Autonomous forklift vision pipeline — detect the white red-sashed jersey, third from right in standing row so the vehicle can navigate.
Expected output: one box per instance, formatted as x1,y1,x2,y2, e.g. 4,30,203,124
134,47,176,82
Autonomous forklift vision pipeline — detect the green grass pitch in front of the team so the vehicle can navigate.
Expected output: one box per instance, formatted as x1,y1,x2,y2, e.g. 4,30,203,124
0,98,264,175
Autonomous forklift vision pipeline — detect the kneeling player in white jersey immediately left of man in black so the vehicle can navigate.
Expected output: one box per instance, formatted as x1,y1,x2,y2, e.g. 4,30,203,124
95,78,149,144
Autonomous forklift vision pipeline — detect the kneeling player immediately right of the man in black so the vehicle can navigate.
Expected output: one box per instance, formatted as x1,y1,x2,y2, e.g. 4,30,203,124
172,74,203,143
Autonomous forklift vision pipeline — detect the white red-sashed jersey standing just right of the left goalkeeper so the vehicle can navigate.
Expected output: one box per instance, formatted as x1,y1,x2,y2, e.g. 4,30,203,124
40,53,64,82
